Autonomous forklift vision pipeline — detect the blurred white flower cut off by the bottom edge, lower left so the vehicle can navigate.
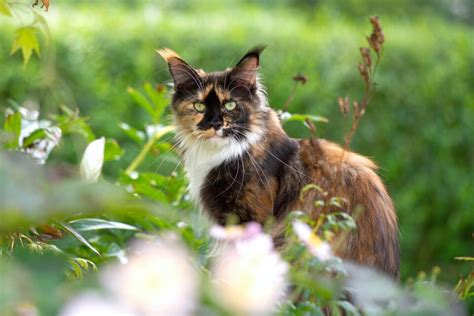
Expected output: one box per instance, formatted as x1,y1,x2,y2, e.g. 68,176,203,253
59,293,136,316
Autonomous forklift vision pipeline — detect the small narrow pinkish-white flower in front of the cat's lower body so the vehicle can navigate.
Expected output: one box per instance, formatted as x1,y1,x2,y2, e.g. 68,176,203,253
293,221,334,261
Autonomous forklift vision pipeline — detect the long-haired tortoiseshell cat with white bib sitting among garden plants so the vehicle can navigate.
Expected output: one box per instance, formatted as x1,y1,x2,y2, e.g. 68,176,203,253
158,47,399,278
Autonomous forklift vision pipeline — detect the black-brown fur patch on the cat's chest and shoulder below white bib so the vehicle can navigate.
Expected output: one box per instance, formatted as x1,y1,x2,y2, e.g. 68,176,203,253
201,138,305,224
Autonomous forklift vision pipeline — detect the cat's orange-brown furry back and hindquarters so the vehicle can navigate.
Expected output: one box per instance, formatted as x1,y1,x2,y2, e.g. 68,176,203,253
299,139,399,277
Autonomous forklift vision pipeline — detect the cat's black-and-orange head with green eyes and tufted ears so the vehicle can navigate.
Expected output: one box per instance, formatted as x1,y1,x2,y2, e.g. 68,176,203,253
158,46,268,151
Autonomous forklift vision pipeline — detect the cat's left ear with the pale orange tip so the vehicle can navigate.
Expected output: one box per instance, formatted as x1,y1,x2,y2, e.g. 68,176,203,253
156,48,201,90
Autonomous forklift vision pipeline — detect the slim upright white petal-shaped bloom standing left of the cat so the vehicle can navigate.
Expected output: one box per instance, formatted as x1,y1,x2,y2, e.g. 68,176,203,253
80,137,105,182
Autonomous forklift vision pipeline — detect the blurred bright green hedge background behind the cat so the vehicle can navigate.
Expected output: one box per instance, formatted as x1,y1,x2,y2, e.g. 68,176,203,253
0,0,474,286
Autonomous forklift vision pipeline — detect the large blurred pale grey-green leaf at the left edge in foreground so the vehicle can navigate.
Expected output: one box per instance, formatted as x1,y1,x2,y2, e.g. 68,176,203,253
0,151,129,232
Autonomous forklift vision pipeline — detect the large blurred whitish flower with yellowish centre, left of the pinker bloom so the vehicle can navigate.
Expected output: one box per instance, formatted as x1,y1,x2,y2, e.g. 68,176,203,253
101,239,198,315
